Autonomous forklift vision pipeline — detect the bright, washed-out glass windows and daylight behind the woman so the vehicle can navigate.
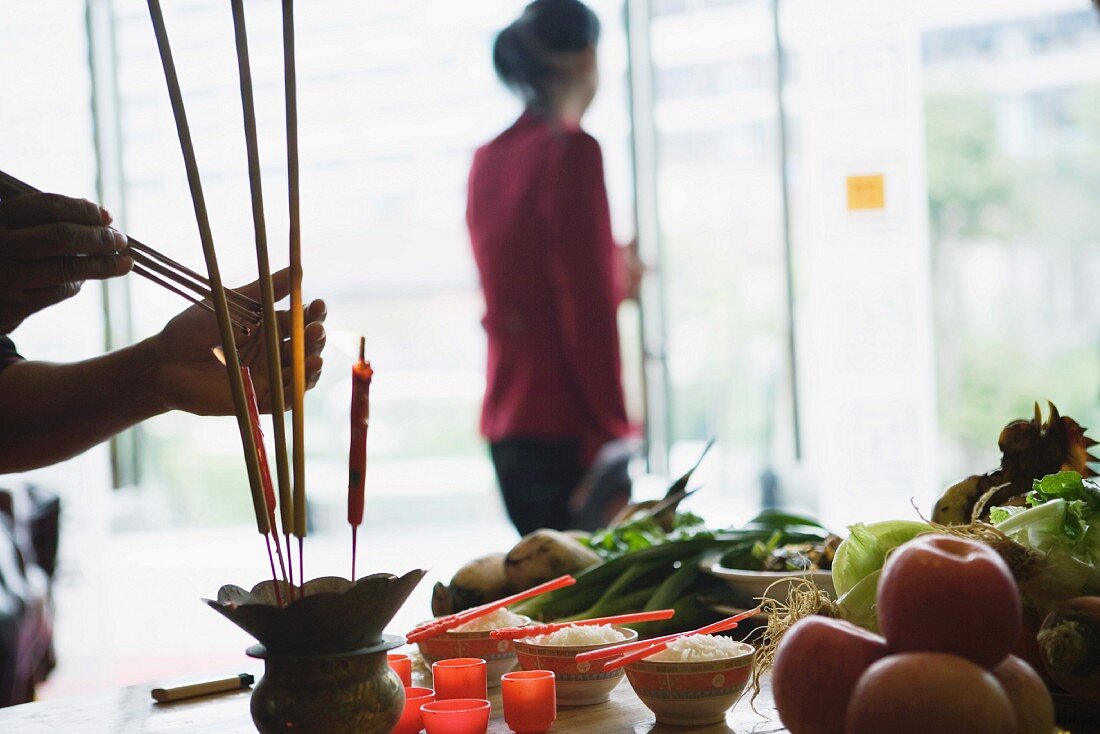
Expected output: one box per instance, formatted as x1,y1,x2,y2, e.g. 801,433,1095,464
0,0,1100,695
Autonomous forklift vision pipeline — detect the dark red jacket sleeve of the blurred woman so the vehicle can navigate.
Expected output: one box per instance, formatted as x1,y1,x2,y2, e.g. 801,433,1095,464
549,133,629,437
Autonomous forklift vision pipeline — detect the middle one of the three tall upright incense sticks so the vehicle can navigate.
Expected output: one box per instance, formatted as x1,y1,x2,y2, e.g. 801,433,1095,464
232,0,294,593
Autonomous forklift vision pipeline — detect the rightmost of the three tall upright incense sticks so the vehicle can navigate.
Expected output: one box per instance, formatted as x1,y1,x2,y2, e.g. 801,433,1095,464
283,0,308,584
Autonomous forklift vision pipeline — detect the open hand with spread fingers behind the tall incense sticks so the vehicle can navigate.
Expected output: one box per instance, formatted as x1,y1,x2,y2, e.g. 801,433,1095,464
153,270,327,415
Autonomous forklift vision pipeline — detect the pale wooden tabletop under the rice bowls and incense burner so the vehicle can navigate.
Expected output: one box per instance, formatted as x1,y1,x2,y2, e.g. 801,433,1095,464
0,670,787,734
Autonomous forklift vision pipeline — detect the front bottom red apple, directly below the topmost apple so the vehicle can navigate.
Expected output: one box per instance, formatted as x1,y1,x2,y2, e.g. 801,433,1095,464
844,653,1019,734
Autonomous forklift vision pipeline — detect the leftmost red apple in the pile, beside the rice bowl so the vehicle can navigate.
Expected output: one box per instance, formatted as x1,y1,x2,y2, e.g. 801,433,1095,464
771,616,887,734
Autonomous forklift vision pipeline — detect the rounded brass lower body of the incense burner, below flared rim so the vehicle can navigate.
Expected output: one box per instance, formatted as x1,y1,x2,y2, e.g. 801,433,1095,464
249,635,405,734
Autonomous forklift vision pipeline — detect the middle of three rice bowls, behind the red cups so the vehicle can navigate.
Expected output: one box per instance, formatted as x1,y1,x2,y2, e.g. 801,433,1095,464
516,624,638,706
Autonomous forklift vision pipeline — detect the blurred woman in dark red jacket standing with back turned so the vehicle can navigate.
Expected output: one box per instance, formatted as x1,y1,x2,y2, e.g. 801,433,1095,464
466,0,640,534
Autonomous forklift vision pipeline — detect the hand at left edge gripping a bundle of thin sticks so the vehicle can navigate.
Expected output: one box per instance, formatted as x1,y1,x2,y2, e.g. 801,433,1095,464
0,193,133,333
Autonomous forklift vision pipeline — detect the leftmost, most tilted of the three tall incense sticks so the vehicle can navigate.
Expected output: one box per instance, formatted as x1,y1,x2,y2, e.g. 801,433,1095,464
147,0,271,536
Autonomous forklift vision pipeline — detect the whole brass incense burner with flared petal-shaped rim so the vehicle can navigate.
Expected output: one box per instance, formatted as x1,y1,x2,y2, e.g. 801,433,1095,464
204,570,425,734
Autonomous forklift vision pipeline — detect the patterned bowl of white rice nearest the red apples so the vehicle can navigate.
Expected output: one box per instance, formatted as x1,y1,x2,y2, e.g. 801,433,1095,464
626,635,756,726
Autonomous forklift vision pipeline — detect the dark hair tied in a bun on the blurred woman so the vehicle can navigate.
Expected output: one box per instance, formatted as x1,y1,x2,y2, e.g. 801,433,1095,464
493,0,600,107
